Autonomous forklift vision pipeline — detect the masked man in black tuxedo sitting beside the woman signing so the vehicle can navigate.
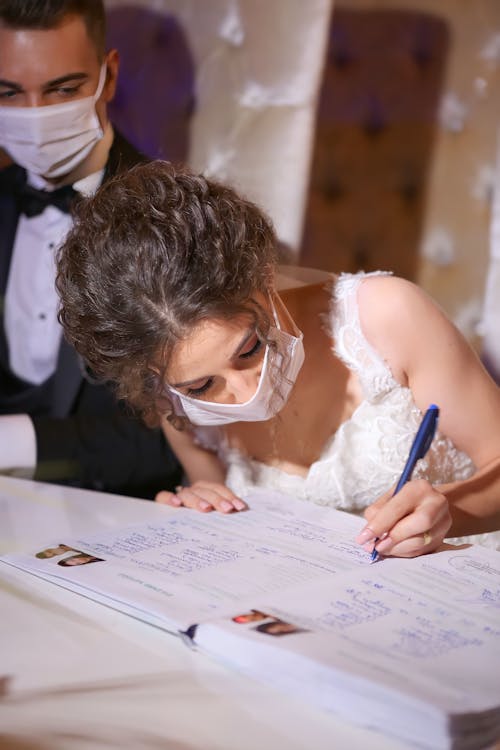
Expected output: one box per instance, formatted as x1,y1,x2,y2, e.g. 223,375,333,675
0,0,181,497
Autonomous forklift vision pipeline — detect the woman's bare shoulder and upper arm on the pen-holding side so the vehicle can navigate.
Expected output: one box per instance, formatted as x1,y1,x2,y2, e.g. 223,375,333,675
352,276,500,467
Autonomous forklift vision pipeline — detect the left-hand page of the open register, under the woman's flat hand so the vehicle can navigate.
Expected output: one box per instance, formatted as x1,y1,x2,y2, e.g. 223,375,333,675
3,492,369,630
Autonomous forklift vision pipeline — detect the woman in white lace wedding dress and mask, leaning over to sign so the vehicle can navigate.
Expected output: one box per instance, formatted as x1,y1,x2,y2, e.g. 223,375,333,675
57,162,500,557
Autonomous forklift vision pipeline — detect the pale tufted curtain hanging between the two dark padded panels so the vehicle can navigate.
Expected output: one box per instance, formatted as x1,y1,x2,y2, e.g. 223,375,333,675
106,0,332,258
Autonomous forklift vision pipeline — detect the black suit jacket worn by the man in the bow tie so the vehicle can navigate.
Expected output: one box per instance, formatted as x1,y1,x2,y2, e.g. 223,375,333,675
0,133,181,497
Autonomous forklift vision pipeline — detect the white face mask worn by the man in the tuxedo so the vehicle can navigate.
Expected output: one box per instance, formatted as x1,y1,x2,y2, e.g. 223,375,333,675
0,64,106,178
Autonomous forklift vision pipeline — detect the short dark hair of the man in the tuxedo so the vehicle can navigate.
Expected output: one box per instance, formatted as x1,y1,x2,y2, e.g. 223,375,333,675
0,0,106,58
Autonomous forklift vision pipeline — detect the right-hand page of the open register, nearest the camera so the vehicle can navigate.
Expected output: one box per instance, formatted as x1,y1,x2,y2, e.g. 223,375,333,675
195,546,500,728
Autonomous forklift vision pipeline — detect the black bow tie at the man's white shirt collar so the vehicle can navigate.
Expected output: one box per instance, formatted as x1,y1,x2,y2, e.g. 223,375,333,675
0,167,78,218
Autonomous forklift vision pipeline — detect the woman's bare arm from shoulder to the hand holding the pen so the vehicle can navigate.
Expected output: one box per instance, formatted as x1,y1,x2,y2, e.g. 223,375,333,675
358,277,500,554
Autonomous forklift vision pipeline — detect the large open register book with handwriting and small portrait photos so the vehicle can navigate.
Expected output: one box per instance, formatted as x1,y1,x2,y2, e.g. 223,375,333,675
2,493,500,750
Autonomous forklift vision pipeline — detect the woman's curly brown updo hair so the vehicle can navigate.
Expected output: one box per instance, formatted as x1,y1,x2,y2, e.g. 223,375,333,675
56,161,277,426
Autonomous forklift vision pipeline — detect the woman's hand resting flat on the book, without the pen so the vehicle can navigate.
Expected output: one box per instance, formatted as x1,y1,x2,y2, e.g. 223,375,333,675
155,481,247,513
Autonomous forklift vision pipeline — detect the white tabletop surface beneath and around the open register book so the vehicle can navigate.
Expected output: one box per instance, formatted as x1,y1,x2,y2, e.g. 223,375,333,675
0,477,468,750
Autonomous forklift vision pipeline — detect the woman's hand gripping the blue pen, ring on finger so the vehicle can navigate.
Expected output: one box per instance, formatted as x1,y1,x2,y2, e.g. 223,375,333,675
356,479,452,557
